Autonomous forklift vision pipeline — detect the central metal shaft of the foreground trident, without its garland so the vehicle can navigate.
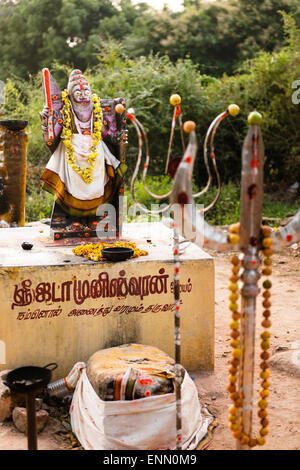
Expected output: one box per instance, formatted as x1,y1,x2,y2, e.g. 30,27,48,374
237,112,264,449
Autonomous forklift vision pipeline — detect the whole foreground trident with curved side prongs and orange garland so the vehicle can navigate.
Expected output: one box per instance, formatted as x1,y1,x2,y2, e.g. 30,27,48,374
172,112,300,450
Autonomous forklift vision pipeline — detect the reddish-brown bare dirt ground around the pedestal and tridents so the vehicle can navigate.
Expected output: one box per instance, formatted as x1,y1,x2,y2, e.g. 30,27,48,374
0,246,300,450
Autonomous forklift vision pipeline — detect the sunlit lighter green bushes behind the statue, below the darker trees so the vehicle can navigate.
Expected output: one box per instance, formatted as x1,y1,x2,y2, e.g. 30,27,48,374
4,16,300,189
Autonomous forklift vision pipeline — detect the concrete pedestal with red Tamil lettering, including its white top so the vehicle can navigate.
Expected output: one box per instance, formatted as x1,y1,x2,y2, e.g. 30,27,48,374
0,223,214,379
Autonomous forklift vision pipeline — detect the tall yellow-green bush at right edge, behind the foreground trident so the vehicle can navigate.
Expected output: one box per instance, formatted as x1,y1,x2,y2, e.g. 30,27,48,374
206,15,300,186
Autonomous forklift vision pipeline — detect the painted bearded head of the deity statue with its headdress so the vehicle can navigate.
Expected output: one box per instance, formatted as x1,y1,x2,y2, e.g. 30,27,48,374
68,71,93,122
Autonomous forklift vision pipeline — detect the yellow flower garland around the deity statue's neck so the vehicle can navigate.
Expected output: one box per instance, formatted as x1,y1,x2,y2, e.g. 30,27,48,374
62,90,103,184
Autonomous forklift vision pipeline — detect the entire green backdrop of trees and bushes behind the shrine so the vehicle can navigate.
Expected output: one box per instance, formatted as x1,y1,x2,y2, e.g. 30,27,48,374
0,0,300,220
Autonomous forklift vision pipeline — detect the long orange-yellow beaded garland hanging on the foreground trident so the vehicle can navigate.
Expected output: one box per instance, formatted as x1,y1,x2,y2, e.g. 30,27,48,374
227,224,273,447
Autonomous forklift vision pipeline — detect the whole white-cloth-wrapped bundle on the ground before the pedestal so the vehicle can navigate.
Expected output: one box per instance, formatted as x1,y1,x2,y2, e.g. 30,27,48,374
70,344,215,450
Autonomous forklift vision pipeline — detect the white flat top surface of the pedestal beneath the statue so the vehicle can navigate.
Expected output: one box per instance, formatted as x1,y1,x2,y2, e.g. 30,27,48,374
0,223,211,267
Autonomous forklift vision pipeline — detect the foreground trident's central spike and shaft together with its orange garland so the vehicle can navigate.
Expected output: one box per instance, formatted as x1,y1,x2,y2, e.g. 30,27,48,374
228,113,272,449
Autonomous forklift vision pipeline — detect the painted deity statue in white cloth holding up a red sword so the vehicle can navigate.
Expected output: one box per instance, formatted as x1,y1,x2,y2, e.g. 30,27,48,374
40,69,127,239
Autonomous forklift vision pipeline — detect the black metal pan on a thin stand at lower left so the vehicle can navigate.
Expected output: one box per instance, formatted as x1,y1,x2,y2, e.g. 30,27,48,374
5,362,57,450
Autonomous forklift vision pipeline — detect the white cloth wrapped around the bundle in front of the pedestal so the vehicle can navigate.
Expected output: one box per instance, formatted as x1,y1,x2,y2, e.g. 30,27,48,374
70,368,213,450
